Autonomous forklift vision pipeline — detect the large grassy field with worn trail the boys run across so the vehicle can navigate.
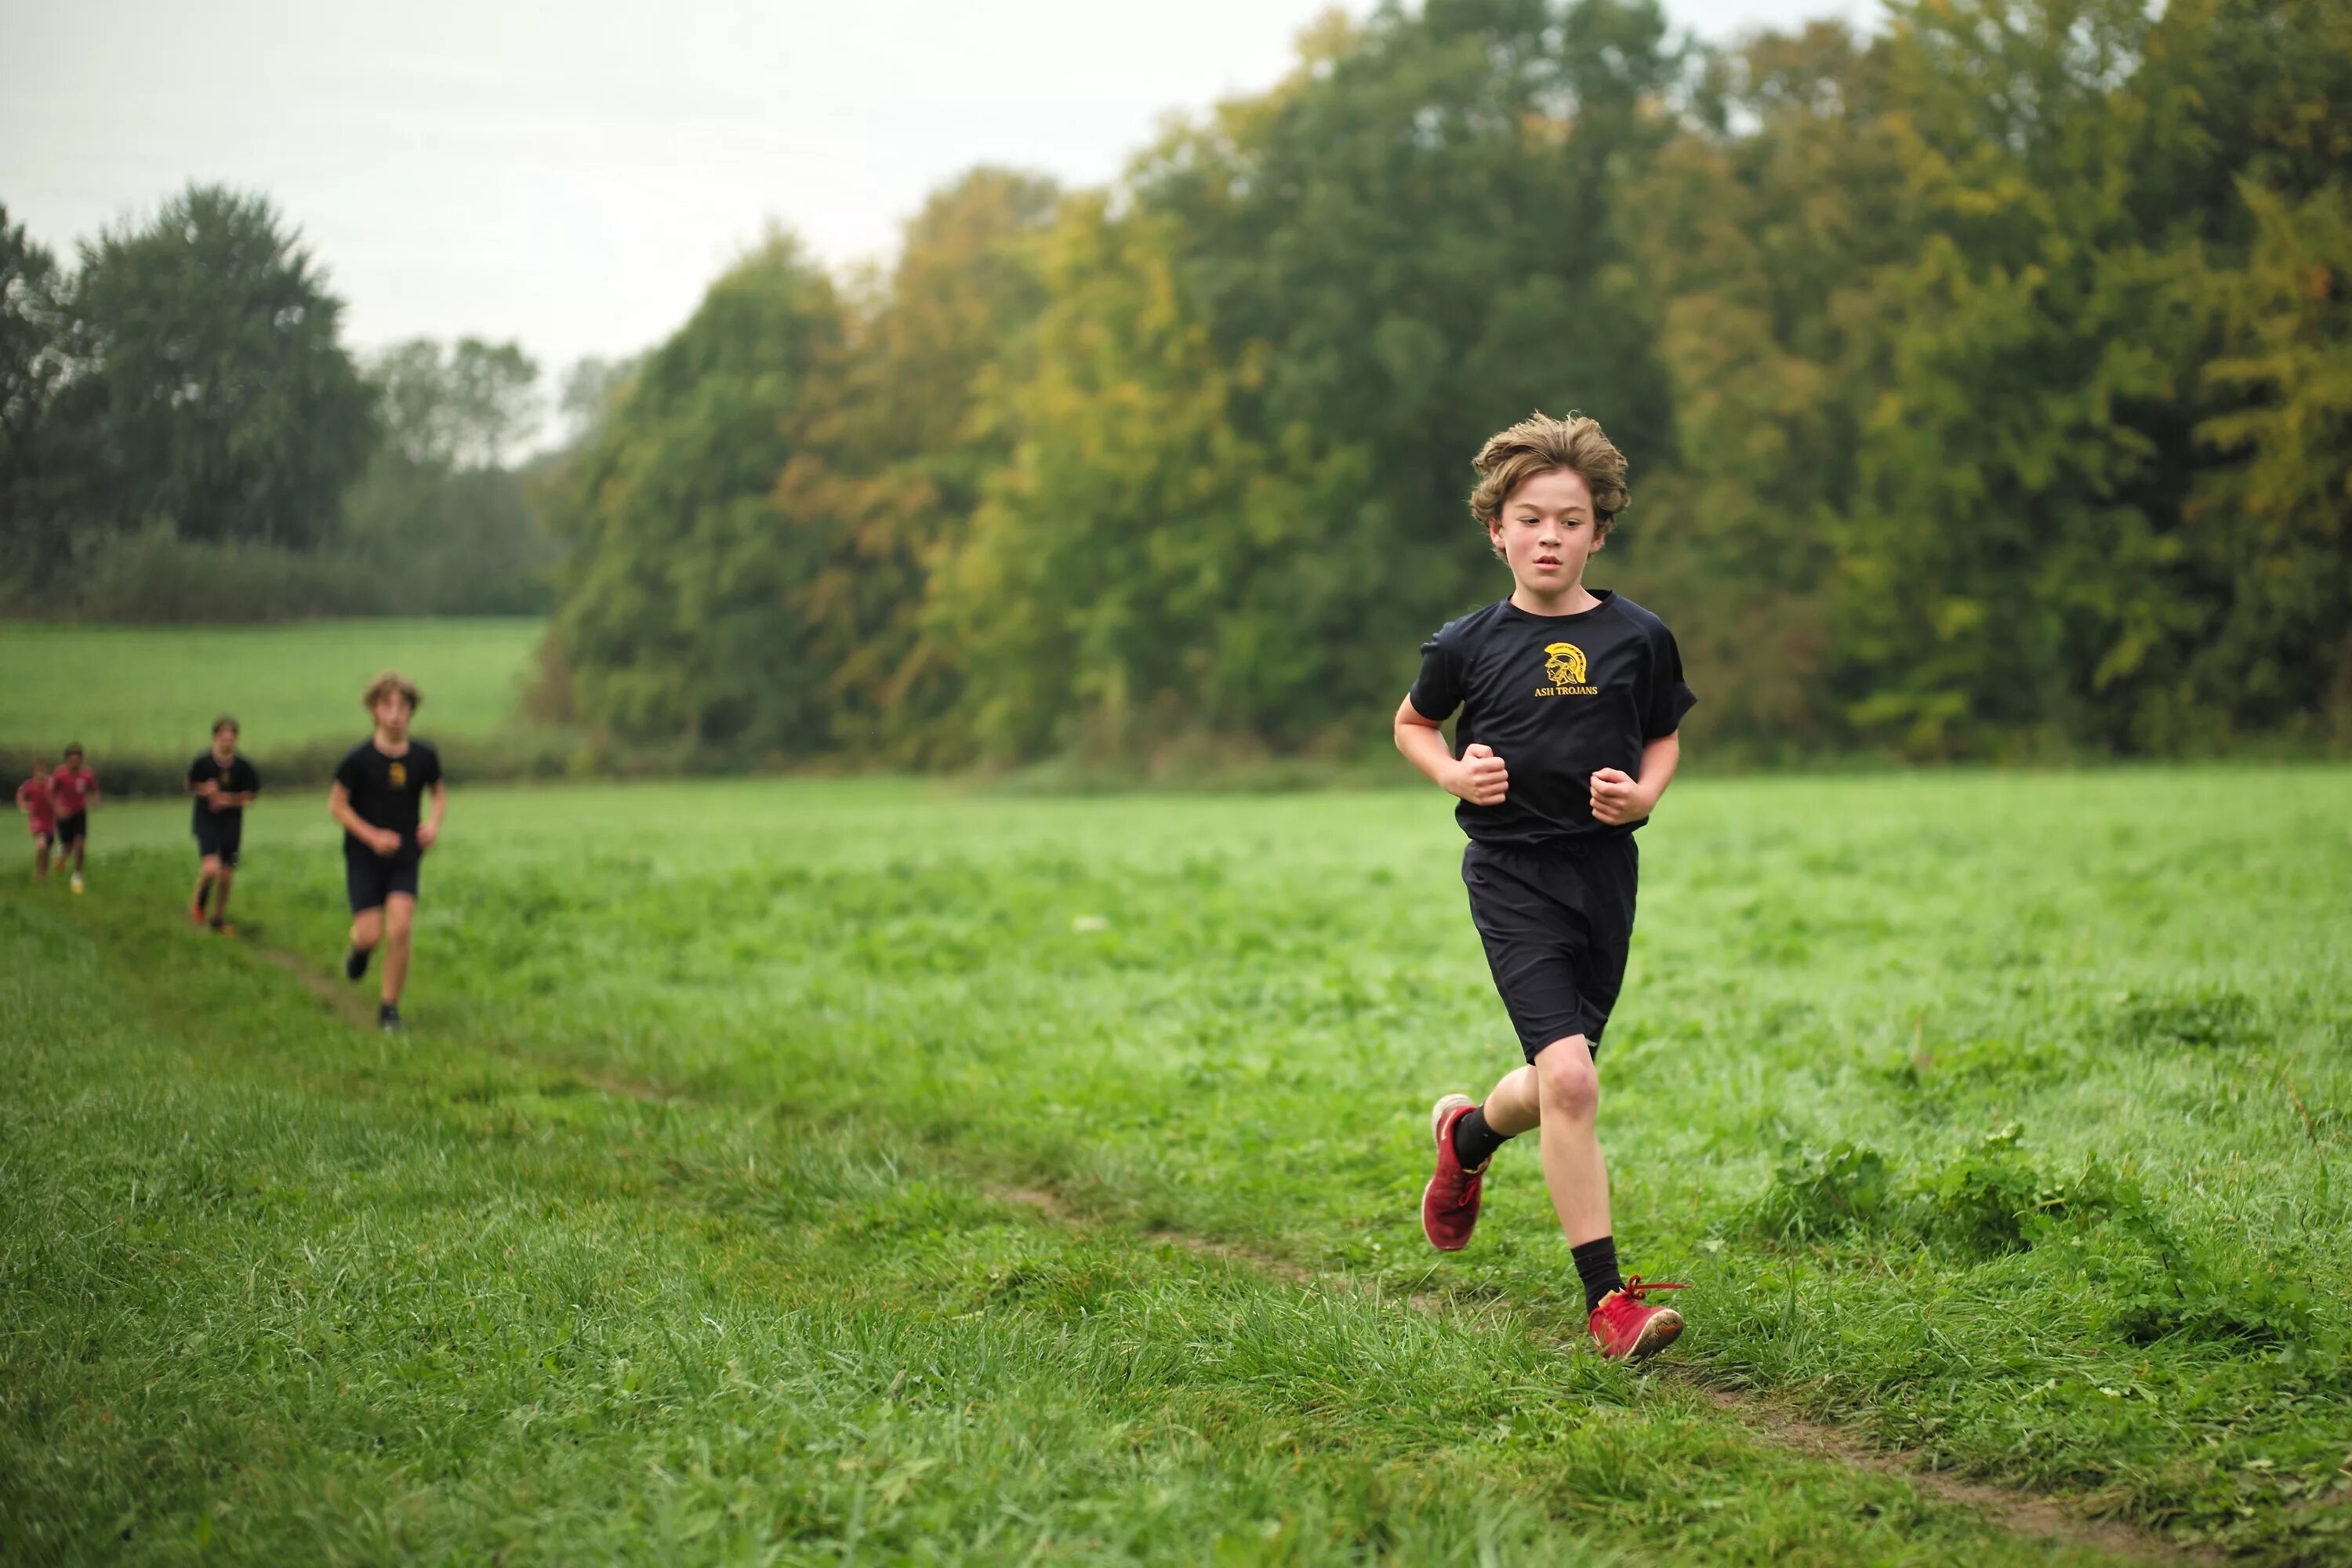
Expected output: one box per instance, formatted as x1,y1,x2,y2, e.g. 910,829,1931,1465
0,769,2352,1563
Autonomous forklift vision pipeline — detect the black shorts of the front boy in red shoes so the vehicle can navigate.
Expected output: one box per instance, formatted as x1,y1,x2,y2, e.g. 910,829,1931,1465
1463,834,1642,1060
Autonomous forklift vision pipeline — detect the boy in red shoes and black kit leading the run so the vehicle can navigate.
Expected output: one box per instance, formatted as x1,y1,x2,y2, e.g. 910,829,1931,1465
1395,414,1696,1359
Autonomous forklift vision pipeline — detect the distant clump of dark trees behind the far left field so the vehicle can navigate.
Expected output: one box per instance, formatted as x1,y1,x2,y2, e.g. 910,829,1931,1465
0,186,555,621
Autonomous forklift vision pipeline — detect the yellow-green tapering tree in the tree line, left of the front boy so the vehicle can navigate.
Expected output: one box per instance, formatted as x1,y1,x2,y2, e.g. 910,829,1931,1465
931,195,1364,762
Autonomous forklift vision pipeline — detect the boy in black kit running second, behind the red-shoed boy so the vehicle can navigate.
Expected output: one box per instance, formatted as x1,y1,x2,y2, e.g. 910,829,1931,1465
327,670,449,1032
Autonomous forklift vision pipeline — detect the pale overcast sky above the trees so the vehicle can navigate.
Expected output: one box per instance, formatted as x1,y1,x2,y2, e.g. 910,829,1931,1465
0,0,1875,380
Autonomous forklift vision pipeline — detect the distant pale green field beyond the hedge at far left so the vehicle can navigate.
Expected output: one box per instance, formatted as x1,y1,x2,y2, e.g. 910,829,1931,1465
0,619,541,757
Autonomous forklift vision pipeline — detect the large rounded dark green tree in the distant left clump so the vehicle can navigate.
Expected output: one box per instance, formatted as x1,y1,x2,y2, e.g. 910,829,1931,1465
66,186,374,546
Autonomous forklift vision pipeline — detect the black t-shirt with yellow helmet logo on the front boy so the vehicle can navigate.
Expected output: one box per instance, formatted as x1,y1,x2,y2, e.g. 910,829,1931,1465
1411,593,1698,846
